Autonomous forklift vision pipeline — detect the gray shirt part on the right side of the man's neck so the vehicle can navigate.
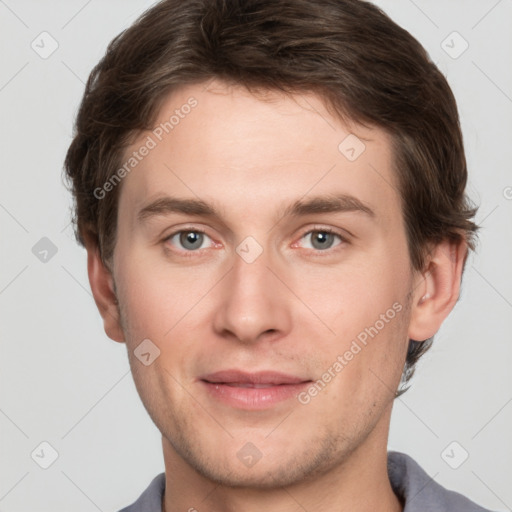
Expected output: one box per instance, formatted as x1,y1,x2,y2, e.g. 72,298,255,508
388,451,491,512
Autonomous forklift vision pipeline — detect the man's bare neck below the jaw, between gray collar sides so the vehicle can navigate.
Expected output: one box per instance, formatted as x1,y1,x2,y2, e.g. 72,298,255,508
162,412,403,512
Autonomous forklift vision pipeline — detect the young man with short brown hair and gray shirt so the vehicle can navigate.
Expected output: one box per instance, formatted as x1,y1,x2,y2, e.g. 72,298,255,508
66,0,484,512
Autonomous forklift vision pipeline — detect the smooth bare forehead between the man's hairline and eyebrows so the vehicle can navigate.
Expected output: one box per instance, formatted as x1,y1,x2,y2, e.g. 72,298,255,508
119,81,398,224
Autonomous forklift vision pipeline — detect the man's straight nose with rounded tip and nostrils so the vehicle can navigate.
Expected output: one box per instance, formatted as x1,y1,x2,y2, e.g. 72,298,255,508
214,243,293,344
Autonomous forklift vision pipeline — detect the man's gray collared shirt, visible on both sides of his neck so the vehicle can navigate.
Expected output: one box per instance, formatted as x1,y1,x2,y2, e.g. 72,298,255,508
119,452,490,512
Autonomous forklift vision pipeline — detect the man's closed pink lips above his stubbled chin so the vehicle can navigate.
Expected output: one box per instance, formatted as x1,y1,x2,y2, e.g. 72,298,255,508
198,370,312,410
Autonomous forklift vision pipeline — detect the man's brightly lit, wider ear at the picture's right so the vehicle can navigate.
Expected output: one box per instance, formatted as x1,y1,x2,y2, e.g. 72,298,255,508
409,238,468,341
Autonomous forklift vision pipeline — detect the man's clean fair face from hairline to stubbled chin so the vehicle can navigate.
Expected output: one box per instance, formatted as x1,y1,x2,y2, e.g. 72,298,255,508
108,82,414,486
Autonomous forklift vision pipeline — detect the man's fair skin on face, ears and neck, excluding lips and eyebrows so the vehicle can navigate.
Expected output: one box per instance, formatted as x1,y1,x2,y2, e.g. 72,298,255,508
87,81,467,512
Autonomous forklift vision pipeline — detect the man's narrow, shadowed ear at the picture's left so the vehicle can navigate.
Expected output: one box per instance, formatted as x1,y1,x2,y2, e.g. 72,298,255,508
86,244,125,343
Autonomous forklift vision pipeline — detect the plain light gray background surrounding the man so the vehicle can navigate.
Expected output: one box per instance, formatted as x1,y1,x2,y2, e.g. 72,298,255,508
0,0,512,512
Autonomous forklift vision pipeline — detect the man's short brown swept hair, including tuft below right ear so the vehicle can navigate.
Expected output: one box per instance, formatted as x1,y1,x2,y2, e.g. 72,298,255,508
65,0,478,394
